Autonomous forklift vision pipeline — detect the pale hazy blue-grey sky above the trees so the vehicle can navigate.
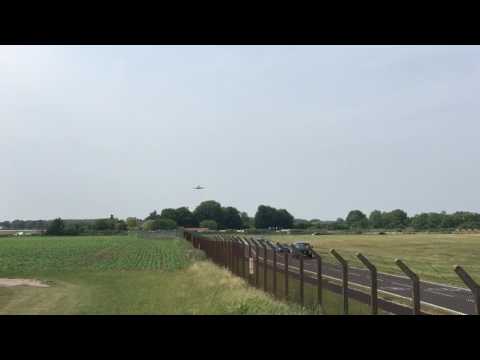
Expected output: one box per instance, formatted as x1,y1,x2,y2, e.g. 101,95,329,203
0,45,480,220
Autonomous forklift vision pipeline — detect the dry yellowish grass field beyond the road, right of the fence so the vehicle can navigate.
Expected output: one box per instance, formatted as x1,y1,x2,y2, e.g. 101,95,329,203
266,233,480,287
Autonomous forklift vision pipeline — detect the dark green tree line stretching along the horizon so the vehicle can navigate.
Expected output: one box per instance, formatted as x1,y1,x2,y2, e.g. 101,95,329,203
0,204,480,235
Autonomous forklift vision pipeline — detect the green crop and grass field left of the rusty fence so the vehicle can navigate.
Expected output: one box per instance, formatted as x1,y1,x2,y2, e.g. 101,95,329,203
0,236,306,314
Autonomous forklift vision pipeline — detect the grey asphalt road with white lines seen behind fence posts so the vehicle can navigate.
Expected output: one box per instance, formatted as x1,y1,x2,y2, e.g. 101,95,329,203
251,246,475,314
